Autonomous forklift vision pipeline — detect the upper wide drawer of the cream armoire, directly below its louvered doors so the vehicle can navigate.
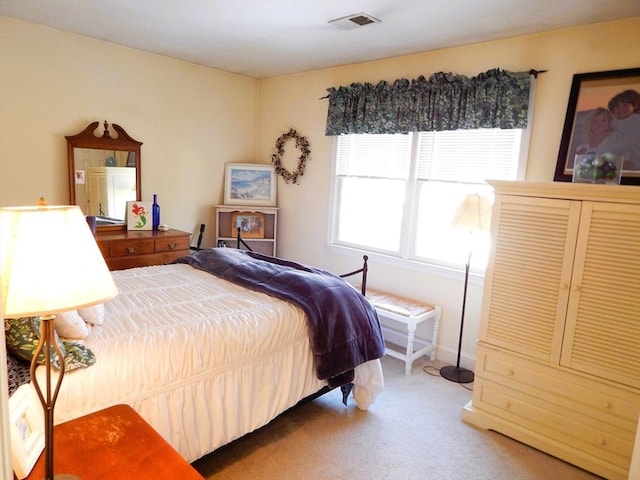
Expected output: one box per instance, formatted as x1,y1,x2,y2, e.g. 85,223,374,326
476,343,640,434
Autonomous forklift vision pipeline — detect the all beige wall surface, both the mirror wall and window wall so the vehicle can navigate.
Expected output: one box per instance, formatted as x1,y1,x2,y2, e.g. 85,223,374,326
0,17,640,374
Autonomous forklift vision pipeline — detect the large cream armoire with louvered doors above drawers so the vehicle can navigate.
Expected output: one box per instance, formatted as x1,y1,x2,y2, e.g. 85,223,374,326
462,181,640,479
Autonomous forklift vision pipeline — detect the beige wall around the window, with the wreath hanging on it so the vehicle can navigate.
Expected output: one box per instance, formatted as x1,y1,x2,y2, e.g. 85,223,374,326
257,17,640,366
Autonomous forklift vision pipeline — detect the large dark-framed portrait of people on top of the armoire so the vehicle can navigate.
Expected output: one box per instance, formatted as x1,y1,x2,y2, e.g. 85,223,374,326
554,67,640,185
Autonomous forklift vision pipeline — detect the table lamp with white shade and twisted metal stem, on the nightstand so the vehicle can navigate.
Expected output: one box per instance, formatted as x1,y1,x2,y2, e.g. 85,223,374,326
0,198,118,480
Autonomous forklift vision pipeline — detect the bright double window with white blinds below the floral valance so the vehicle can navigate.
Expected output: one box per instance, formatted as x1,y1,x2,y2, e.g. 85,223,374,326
331,129,523,266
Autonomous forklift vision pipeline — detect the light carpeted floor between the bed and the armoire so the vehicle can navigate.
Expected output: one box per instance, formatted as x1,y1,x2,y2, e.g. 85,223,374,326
193,357,599,480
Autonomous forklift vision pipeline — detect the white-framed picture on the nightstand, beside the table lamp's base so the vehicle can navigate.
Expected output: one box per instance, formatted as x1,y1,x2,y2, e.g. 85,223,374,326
9,384,44,479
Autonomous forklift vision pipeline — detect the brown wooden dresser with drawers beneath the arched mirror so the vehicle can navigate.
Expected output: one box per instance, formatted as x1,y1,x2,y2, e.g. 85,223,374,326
96,230,191,270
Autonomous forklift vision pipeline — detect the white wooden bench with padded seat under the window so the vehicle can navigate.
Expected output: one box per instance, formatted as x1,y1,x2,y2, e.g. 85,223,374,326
366,288,442,375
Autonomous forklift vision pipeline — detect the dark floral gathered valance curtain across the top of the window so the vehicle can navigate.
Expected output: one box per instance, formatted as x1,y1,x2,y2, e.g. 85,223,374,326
325,69,532,135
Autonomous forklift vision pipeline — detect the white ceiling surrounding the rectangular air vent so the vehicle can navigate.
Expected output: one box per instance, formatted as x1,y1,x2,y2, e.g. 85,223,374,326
0,0,640,78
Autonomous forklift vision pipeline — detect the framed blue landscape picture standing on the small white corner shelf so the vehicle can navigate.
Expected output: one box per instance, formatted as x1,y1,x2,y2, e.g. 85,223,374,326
224,163,276,207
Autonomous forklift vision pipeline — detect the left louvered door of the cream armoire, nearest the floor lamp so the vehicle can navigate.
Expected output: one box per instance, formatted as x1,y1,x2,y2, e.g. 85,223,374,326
480,195,581,365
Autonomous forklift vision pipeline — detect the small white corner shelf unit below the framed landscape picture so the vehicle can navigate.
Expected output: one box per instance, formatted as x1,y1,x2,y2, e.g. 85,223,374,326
215,205,278,257
